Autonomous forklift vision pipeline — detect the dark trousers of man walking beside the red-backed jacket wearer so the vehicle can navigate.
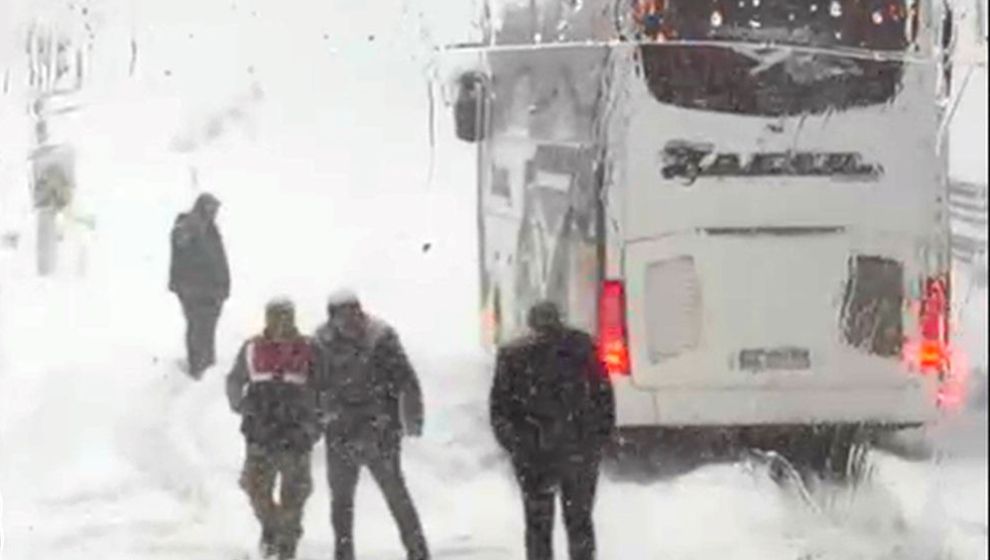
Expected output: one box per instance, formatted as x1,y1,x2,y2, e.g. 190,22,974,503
326,437,429,560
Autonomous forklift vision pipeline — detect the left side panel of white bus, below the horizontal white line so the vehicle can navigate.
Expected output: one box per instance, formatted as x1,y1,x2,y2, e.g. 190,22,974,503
479,47,606,344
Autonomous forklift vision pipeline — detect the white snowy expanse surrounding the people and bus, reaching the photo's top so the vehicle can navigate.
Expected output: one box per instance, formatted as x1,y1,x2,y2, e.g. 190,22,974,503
0,0,988,560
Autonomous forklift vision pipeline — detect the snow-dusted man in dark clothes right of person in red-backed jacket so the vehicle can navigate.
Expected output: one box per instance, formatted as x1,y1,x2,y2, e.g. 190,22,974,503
316,291,429,560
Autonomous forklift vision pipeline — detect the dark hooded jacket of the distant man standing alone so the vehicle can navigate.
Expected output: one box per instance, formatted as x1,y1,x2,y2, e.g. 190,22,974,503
168,195,230,300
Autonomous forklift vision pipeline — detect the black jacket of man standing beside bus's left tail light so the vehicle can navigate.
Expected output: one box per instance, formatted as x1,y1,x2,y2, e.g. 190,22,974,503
490,328,615,463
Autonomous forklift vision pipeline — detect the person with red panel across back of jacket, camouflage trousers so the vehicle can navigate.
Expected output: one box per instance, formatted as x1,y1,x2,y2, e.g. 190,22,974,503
227,300,321,560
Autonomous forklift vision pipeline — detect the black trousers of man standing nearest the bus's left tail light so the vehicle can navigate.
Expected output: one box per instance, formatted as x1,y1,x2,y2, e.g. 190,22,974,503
513,455,600,560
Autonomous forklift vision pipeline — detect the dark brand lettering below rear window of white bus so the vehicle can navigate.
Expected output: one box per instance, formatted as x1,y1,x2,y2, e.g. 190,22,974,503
660,140,883,185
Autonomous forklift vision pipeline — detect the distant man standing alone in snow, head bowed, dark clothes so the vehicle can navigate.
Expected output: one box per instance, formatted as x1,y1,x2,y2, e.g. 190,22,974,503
168,190,230,379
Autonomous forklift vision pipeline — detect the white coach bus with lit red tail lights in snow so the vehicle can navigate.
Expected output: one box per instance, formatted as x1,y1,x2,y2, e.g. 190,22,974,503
455,0,951,466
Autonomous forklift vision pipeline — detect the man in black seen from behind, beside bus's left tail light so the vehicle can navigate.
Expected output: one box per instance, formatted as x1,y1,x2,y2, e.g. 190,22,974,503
490,302,615,560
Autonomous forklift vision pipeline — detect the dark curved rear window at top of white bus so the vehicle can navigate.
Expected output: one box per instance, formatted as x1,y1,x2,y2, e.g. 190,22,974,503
632,0,918,116
